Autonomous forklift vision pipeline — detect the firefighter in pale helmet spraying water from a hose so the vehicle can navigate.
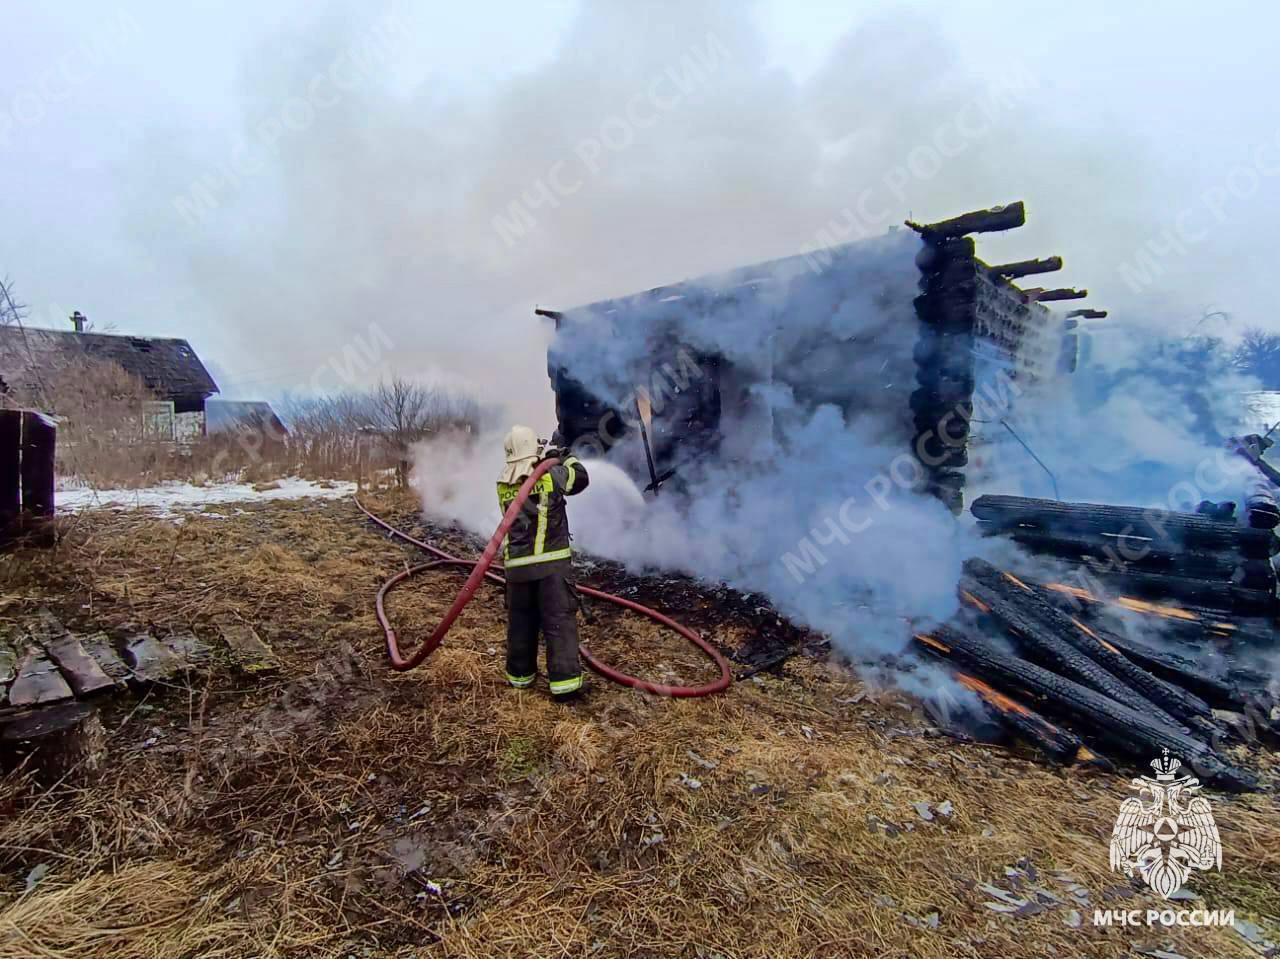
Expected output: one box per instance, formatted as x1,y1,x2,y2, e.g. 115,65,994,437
498,426,588,702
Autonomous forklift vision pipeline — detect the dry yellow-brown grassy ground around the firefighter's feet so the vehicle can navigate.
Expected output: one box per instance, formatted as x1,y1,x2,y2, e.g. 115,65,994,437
0,496,1280,959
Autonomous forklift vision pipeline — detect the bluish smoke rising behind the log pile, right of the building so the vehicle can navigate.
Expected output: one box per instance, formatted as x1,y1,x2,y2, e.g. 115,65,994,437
970,325,1261,512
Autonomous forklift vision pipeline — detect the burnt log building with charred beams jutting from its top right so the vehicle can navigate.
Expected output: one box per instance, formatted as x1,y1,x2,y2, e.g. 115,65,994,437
538,202,1105,512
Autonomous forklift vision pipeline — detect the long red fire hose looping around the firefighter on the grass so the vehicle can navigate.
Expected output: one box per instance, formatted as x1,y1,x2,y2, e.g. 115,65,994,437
356,460,732,697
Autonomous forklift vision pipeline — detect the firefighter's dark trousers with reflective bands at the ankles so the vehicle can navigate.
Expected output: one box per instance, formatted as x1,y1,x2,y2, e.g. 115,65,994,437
507,572,582,695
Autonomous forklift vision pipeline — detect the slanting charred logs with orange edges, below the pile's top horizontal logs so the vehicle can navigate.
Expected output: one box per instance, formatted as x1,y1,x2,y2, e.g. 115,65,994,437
915,560,1280,790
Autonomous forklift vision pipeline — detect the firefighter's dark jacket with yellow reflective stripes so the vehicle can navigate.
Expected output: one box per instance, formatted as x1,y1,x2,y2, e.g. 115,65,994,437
498,456,589,583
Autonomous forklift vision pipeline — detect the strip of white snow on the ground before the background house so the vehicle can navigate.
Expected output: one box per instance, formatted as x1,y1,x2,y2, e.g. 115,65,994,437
55,476,356,517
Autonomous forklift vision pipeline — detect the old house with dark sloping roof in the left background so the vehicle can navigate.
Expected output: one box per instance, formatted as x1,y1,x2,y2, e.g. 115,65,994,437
0,326,218,443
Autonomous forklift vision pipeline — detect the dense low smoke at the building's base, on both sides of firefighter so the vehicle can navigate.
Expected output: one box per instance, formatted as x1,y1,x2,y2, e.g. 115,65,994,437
415,419,978,658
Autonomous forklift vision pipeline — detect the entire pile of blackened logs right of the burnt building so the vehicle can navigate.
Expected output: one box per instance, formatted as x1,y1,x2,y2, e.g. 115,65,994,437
916,494,1280,789
